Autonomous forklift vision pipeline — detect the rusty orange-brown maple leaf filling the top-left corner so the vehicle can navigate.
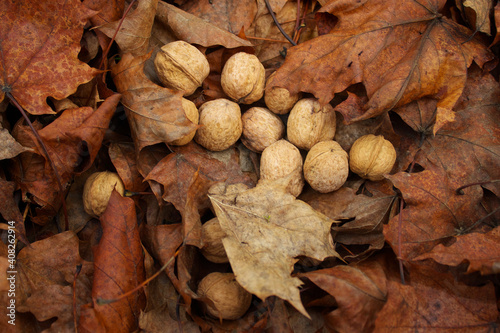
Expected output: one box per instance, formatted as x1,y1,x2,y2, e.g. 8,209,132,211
0,0,98,114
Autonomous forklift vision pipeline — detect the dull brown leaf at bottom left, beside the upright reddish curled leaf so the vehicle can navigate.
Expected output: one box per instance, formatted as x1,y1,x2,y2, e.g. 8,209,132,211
16,231,92,332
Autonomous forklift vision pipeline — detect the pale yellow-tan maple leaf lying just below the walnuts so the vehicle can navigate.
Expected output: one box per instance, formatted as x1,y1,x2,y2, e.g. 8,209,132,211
209,181,338,318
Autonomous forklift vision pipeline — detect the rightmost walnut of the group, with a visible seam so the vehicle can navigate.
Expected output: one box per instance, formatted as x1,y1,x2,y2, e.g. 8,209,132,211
349,134,396,180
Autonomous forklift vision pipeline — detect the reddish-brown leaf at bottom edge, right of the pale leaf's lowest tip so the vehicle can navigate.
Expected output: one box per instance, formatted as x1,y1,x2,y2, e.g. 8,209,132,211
300,253,387,332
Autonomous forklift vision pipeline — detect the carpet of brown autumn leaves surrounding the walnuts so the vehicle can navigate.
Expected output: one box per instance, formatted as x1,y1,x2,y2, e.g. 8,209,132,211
0,0,500,333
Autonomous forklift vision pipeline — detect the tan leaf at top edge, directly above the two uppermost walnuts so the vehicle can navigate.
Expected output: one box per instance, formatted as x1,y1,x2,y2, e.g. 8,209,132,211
156,2,252,48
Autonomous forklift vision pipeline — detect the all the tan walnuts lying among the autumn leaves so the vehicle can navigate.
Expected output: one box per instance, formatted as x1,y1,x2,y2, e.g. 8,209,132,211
83,41,396,320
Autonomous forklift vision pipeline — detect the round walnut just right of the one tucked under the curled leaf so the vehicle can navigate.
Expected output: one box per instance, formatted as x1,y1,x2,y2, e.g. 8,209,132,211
194,98,243,151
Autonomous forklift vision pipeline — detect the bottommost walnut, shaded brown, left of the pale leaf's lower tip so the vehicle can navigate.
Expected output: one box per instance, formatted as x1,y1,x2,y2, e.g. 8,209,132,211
197,272,252,320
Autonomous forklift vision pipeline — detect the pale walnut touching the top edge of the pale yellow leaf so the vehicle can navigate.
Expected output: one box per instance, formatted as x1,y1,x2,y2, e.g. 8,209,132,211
260,140,304,196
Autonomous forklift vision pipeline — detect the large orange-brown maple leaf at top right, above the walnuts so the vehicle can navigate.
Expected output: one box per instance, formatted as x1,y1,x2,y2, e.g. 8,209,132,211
266,0,493,126
